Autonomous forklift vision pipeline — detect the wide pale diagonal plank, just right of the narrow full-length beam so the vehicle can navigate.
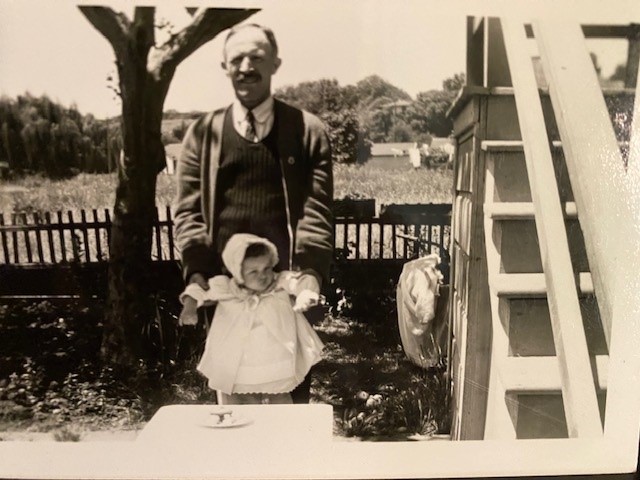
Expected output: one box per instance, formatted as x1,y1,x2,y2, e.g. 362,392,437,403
533,19,625,343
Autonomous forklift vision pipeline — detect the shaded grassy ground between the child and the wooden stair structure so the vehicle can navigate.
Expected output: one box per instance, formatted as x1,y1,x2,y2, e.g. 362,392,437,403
312,316,450,441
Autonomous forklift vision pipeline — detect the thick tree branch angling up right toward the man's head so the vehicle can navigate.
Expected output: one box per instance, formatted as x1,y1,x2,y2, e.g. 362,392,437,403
156,8,260,75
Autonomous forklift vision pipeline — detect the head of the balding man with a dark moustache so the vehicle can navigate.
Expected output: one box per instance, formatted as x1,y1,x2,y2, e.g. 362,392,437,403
222,24,281,109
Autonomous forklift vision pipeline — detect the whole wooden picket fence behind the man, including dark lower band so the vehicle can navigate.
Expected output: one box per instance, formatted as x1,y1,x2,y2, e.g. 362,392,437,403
0,201,451,297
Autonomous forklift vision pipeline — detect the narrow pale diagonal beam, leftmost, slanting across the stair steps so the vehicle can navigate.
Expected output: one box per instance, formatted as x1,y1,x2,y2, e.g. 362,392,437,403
502,18,602,437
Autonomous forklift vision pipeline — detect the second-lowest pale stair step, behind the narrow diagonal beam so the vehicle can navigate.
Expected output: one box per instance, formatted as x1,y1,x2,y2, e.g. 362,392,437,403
490,272,594,297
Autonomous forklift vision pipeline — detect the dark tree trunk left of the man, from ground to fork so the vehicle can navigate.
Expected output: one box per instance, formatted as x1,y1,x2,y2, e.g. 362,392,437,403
101,17,173,367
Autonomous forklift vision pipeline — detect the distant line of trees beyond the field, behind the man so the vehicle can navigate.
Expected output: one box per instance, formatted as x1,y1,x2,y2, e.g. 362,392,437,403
0,74,464,173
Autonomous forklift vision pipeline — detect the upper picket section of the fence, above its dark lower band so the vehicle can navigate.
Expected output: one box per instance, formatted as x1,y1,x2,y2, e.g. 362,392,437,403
0,205,451,265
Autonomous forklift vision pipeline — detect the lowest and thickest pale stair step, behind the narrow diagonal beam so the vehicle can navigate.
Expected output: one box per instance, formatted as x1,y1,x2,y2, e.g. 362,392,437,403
498,355,609,393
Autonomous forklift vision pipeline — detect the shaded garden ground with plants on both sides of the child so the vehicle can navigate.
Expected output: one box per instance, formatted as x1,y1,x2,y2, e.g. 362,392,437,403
0,300,449,441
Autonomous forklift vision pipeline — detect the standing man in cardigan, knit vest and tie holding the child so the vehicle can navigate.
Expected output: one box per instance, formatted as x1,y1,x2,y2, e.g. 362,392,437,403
174,24,333,403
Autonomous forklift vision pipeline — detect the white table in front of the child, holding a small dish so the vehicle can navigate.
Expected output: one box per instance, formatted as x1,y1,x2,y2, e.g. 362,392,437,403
136,404,333,450
